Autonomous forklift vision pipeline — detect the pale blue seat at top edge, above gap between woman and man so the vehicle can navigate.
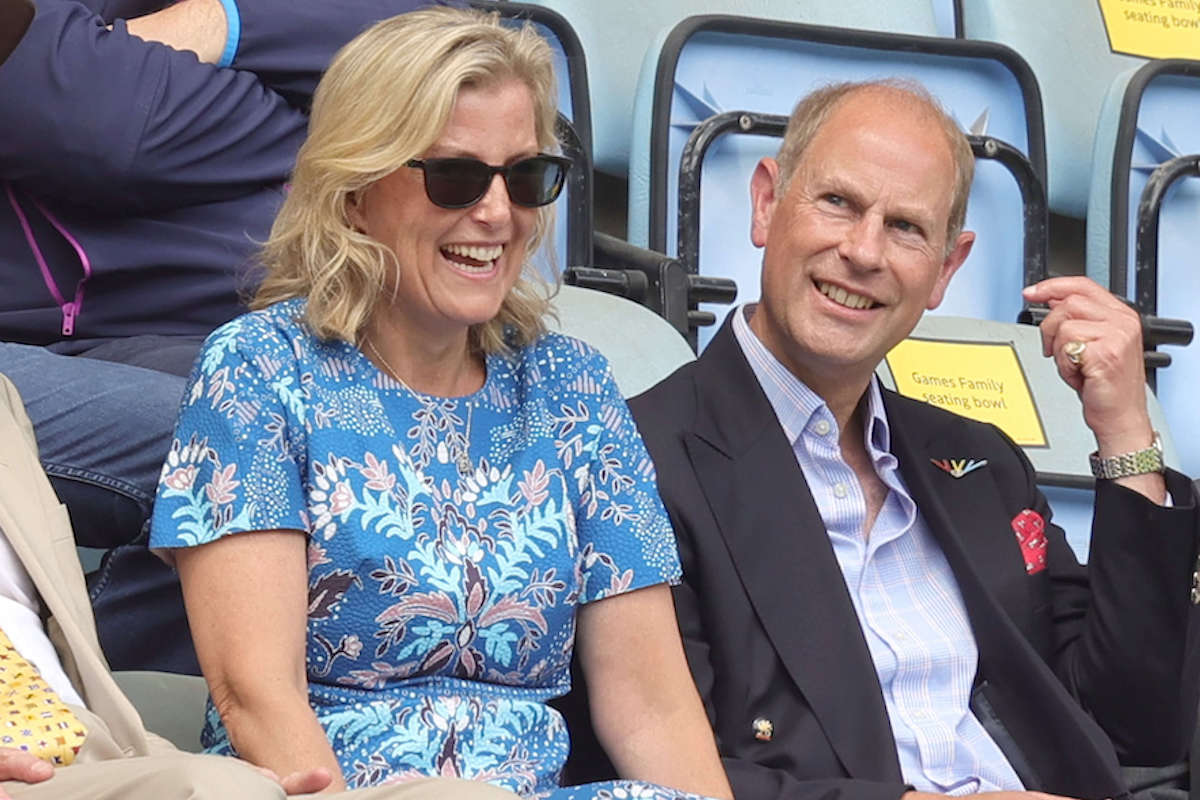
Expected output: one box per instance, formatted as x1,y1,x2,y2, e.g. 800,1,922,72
511,0,946,176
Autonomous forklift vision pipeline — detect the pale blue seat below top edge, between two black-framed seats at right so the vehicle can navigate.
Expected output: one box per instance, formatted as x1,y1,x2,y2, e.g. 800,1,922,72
958,0,1142,218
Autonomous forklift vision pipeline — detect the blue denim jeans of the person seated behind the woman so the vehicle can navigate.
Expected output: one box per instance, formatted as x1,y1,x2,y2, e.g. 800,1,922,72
0,342,199,673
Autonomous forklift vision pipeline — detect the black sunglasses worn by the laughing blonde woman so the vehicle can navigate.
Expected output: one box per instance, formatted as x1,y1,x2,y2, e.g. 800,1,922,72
404,155,571,209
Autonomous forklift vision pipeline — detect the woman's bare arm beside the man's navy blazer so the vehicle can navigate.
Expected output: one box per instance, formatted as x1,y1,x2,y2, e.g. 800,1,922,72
577,584,733,799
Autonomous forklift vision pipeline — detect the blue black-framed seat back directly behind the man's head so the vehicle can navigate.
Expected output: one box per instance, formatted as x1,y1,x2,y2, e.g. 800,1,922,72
630,16,1044,341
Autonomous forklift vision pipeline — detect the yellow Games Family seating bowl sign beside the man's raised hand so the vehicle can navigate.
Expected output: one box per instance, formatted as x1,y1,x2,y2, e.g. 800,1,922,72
887,338,1046,447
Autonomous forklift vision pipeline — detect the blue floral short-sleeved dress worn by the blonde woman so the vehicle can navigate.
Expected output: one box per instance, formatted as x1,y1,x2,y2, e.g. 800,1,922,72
150,300,690,800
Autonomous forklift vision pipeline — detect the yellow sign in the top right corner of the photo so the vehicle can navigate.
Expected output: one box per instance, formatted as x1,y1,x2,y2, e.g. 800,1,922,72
1099,0,1200,59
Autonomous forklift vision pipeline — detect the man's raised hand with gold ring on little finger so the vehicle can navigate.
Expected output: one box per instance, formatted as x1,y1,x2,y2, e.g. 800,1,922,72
1022,277,1153,456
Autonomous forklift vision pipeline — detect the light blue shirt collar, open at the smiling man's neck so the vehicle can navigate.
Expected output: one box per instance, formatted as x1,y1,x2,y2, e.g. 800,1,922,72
733,303,892,462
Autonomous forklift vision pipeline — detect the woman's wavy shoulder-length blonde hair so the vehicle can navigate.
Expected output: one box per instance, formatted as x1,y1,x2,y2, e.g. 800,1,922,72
251,7,557,353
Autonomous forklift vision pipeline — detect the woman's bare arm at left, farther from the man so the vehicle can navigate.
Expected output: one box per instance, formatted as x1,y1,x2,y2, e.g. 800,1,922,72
173,530,346,790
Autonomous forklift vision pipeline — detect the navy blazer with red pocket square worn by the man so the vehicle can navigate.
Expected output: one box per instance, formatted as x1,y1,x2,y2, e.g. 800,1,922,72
630,323,1200,800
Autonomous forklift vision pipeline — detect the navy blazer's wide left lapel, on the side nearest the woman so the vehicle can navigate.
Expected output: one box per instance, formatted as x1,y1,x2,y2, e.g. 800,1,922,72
684,324,901,781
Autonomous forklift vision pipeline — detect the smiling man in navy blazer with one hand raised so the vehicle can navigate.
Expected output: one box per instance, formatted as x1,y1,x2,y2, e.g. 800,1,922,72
631,82,1200,800
